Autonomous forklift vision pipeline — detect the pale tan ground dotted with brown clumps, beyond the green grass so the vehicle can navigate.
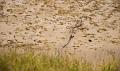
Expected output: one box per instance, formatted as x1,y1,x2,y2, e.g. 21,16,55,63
0,0,120,63
